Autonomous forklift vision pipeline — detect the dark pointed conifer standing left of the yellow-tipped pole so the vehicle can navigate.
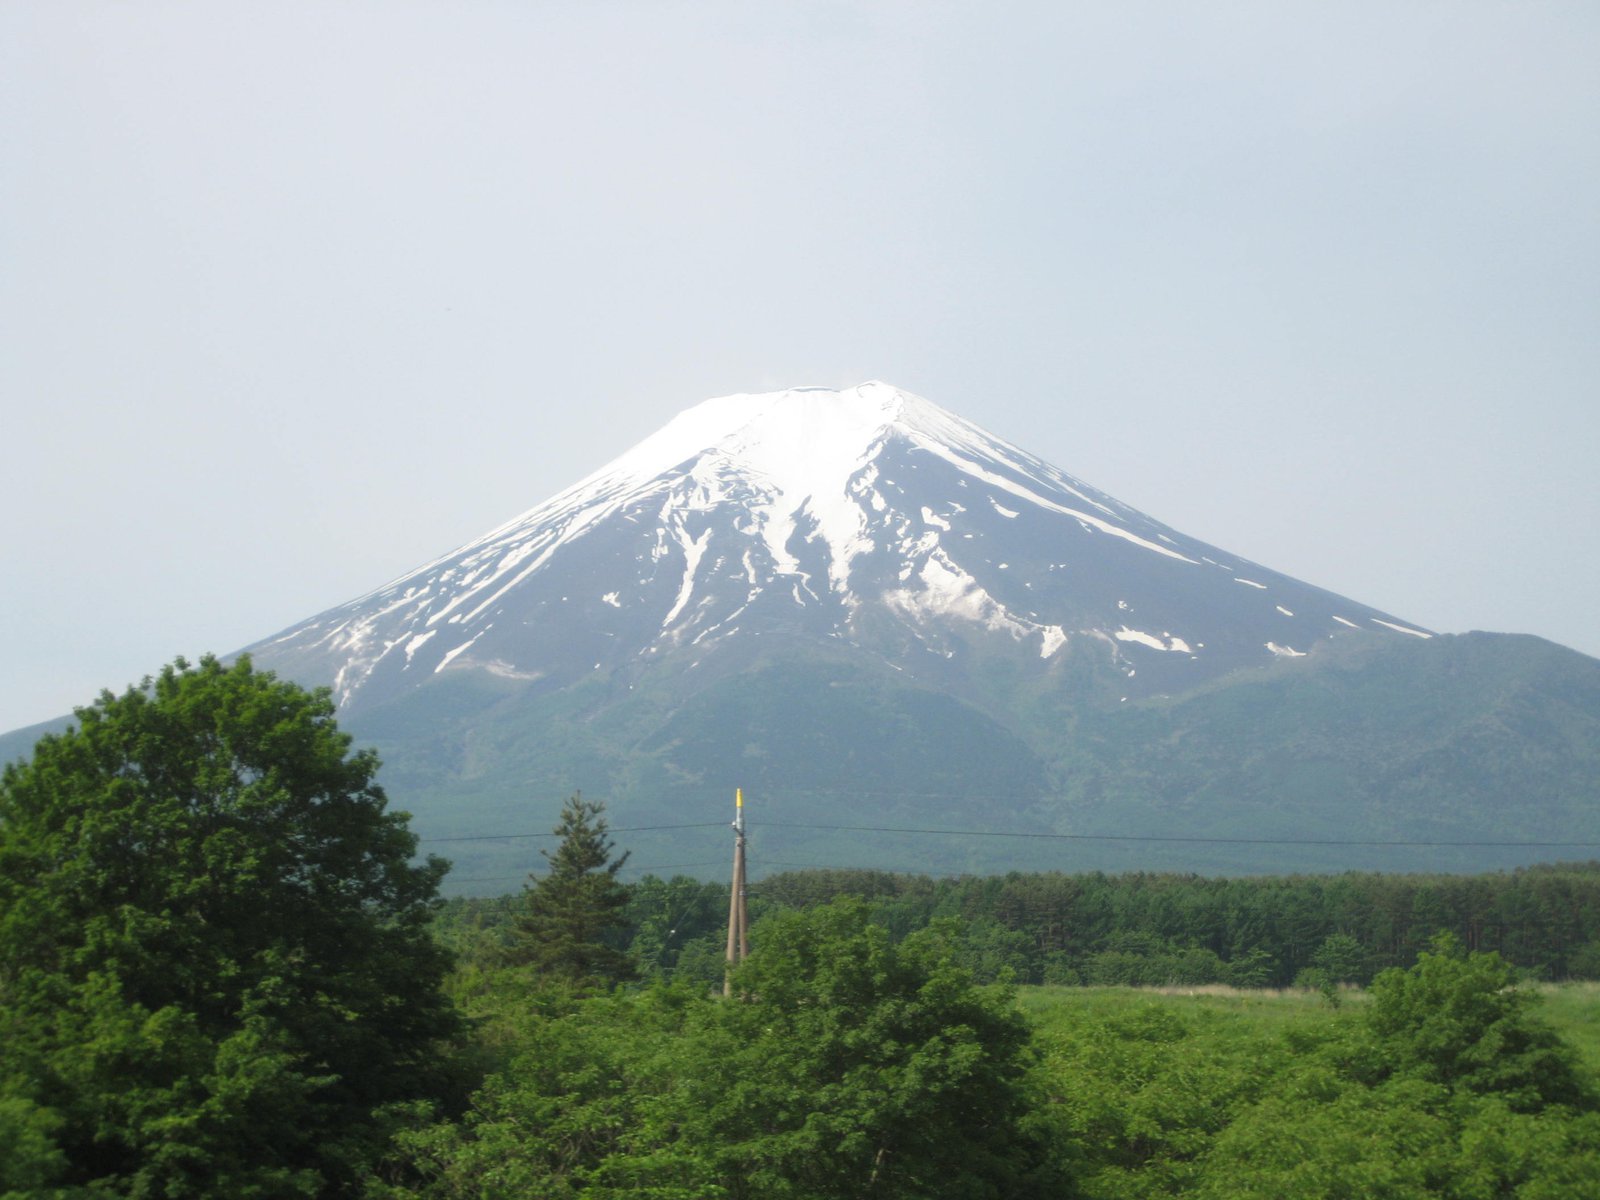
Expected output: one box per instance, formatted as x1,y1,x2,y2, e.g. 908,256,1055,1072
510,794,637,989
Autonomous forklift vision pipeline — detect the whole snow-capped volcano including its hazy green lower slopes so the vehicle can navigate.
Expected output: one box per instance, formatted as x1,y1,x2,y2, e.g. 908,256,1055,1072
0,382,1600,891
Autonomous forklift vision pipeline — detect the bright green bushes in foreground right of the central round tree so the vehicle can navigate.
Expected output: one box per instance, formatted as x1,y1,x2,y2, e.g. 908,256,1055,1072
1027,939,1600,1200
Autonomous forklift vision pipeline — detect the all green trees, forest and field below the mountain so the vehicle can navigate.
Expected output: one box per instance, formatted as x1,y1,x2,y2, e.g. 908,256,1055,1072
9,659,1600,1200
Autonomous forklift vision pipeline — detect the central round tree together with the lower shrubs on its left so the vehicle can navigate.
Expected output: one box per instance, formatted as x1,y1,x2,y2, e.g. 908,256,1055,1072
389,901,1061,1200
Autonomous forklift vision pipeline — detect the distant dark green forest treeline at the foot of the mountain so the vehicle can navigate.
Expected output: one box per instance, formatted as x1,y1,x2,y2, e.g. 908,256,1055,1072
435,862,1600,987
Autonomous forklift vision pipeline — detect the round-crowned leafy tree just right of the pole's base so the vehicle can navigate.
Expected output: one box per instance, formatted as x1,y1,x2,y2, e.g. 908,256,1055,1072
667,899,1061,1200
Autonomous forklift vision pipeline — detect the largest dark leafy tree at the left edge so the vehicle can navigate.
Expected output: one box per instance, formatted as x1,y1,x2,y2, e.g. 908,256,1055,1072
0,656,458,1198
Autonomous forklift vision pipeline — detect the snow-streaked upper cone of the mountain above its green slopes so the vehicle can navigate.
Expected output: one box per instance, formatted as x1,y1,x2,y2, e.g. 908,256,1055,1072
251,382,1429,710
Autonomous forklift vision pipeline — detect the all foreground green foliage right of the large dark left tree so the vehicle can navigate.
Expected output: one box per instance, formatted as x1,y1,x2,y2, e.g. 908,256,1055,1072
384,899,1600,1200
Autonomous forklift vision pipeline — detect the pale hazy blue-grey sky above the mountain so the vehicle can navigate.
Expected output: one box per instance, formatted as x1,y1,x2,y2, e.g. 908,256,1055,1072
0,0,1600,730
